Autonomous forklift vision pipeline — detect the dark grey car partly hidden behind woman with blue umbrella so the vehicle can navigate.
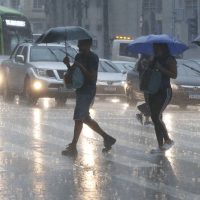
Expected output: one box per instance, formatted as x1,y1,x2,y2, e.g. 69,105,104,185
125,59,200,108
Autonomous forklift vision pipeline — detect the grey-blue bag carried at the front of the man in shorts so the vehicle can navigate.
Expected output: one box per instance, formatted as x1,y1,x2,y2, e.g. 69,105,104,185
64,67,85,89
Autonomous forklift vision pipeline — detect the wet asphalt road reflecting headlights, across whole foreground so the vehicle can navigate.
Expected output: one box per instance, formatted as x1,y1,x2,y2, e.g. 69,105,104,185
0,99,200,200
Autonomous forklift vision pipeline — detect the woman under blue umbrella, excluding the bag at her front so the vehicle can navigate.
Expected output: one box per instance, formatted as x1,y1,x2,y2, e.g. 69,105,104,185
148,43,177,153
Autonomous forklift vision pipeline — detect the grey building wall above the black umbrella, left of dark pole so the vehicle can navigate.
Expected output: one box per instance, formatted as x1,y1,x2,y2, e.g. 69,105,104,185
45,0,105,57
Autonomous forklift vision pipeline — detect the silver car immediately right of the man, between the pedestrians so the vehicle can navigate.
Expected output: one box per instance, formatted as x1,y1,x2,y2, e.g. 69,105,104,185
97,59,126,97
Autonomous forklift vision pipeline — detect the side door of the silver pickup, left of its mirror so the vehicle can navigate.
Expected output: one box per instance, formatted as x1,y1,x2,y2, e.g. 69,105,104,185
7,46,23,90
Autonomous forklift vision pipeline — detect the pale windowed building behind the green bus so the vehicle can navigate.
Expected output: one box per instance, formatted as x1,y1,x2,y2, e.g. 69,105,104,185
0,0,46,33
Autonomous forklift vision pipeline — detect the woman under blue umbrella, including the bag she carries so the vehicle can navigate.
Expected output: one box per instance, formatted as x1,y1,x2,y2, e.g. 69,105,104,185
144,43,177,153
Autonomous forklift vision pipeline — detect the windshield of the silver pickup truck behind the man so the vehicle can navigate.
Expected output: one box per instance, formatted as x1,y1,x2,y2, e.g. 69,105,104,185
30,46,77,62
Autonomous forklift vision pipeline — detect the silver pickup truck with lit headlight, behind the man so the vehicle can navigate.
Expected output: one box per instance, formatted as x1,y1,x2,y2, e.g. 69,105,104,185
1,43,77,104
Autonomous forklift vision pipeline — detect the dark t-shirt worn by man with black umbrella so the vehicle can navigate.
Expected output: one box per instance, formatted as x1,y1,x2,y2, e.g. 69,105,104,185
75,52,99,94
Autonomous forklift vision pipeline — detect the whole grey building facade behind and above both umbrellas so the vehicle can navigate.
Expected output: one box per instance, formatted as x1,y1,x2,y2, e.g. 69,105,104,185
45,0,200,57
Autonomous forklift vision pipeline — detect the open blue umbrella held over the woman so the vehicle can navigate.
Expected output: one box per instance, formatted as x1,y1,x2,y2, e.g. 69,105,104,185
128,34,189,55
